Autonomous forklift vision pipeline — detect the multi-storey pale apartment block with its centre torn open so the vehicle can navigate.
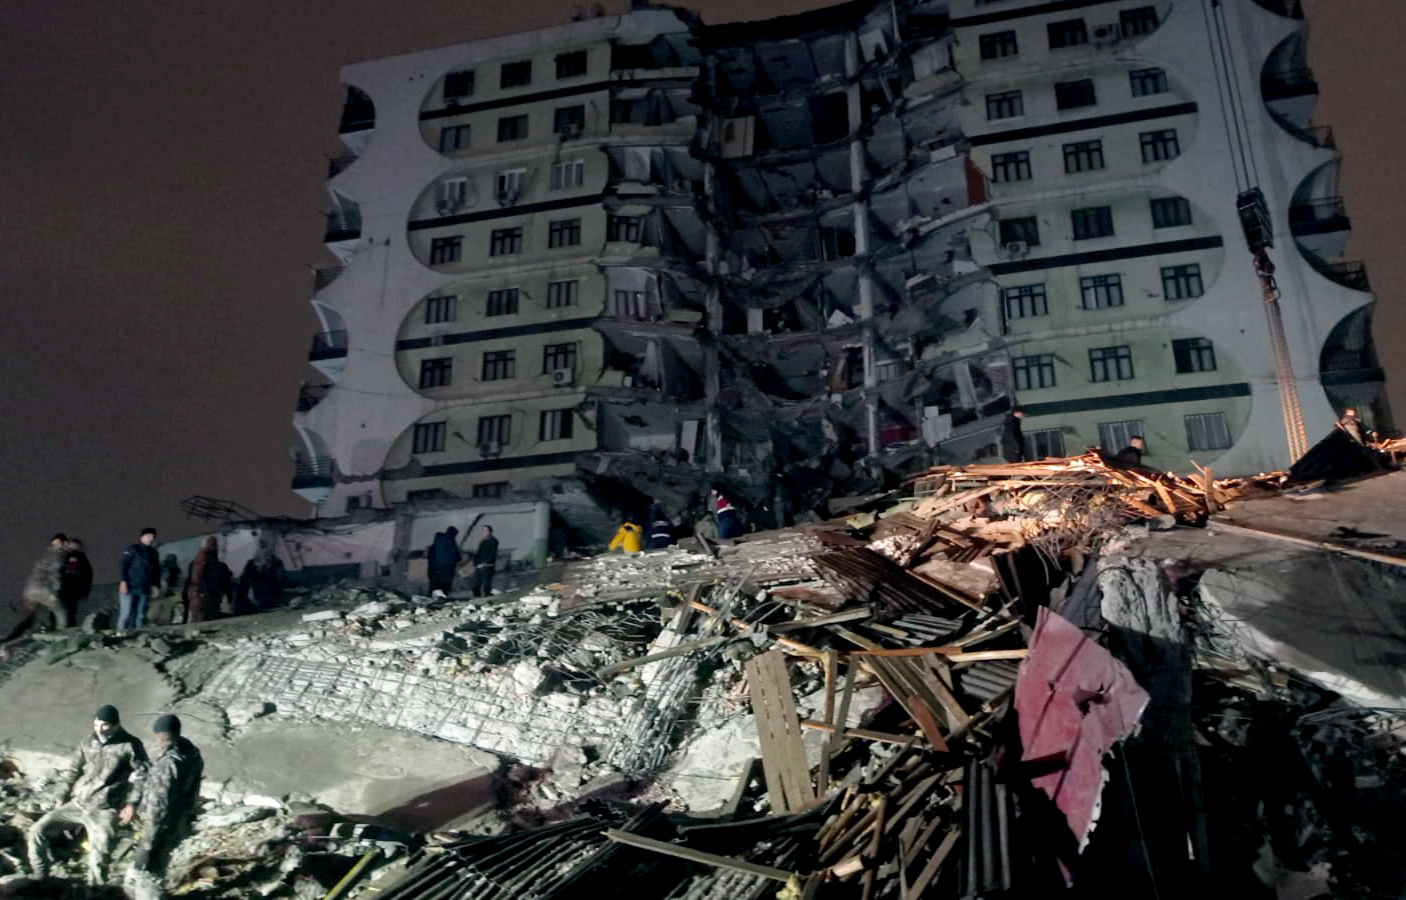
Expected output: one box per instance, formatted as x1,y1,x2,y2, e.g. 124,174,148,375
294,0,1388,523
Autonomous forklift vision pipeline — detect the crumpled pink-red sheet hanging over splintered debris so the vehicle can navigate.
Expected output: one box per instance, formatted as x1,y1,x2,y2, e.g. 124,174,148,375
1015,609,1150,851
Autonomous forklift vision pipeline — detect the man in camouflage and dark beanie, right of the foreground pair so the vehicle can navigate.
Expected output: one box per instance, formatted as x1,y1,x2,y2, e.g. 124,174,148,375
118,714,205,900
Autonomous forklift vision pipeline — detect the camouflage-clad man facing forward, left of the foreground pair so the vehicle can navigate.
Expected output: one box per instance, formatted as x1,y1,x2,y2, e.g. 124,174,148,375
28,706,146,885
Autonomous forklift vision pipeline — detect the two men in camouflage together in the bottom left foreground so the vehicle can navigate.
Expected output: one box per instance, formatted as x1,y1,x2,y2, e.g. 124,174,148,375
27,706,205,900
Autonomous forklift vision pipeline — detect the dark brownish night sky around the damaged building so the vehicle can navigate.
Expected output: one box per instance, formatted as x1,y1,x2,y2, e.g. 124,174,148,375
0,0,1406,590
